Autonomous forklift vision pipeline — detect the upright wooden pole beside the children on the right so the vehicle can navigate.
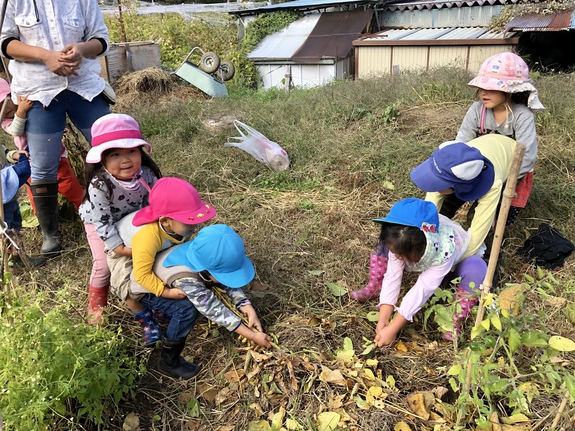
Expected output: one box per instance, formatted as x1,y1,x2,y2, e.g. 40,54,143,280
465,144,525,393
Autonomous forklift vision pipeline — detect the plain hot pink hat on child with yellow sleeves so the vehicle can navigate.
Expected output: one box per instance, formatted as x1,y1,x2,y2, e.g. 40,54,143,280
132,177,216,226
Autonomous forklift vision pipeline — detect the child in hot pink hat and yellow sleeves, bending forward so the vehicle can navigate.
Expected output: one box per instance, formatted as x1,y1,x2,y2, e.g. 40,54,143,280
108,178,216,346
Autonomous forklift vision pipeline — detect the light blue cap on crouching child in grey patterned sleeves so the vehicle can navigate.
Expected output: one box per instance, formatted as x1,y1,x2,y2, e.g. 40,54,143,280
163,224,255,288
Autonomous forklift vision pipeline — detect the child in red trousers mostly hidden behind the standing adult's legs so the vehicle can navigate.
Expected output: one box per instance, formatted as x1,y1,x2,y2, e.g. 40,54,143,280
0,78,84,230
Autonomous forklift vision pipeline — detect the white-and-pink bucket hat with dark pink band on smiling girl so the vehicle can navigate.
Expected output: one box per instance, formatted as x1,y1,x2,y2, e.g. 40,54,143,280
86,114,152,163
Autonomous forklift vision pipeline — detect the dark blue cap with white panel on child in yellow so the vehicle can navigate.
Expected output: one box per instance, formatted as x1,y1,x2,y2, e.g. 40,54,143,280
410,141,495,202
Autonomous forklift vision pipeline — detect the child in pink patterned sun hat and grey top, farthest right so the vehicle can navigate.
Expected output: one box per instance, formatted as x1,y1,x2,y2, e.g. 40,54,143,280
455,52,545,224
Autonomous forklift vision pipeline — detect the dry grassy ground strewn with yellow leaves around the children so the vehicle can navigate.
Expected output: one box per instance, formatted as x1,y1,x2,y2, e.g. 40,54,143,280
4,70,575,431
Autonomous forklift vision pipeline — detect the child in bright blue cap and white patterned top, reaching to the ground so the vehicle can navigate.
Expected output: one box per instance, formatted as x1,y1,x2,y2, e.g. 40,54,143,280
364,198,487,347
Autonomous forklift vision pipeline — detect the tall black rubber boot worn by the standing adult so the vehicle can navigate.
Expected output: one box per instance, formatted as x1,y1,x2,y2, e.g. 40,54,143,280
30,181,62,257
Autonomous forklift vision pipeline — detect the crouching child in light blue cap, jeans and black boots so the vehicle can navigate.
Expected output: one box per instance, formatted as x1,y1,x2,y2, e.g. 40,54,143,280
112,224,271,379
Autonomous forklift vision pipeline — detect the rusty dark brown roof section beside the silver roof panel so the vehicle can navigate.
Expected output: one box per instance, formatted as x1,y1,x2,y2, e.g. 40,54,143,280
292,10,373,62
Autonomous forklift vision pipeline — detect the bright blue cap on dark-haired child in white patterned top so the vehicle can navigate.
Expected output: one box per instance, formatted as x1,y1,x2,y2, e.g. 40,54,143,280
373,198,439,232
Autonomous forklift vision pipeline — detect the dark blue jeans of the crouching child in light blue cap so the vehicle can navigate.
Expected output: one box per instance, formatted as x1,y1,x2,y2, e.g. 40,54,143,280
140,293,198,340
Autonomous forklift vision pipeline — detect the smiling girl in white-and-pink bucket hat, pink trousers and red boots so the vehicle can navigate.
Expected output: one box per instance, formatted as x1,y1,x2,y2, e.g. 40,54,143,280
79,114,161,323
